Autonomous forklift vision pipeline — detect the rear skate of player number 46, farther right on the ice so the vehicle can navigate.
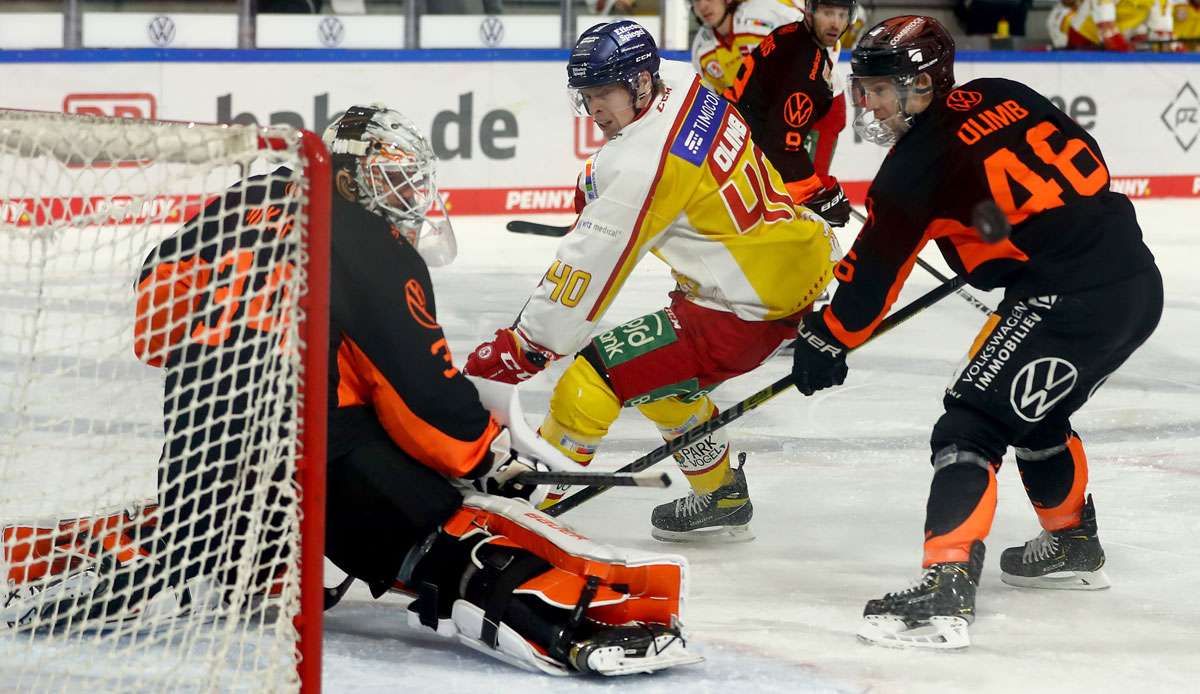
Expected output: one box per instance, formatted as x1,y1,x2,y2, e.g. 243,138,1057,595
1000,495,1110,591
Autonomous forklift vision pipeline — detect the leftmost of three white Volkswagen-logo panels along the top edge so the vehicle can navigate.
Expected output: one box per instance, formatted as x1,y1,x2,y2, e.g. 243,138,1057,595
83,12,238,48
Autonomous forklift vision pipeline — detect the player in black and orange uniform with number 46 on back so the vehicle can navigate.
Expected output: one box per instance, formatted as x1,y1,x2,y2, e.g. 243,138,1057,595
793,17,1163,647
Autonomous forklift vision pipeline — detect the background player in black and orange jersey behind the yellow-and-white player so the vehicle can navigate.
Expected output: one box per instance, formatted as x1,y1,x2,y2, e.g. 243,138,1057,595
724,0,857,227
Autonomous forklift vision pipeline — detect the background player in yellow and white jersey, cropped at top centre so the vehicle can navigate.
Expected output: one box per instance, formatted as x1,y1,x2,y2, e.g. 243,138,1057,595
689,0,804,94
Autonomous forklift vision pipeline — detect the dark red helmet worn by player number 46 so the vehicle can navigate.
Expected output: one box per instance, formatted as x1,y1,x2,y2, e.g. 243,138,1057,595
850,14,954,94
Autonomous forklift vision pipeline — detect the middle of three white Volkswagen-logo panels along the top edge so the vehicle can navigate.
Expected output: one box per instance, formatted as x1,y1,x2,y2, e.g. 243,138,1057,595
254,14,404,48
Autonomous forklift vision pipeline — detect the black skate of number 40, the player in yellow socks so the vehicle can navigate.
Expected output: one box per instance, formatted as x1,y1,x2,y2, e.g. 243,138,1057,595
650,453,754,543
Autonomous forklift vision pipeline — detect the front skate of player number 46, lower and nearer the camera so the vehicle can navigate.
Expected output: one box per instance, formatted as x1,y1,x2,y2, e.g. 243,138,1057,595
858,540,984,650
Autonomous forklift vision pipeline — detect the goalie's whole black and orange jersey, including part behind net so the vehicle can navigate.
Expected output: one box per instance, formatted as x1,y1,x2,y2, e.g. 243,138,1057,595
134,169,499,477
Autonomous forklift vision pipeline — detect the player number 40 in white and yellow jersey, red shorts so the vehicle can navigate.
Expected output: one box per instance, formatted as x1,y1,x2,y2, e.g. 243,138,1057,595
464,20,840,540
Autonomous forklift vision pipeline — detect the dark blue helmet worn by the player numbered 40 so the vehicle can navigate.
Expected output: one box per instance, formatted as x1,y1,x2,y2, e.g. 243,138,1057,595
566,19,659,113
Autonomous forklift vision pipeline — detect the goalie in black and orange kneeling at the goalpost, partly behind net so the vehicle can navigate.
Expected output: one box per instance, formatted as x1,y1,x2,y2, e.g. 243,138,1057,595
7,106,697,675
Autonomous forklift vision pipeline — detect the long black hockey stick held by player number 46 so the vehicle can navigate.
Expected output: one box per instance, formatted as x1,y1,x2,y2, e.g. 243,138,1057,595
544,272,964,516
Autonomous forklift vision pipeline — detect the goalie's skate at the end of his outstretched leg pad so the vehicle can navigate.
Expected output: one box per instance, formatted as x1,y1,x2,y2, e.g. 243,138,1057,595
570,624,704,676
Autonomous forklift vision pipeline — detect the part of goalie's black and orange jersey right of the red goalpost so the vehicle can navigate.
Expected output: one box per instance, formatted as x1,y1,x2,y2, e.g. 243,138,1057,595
329,192,499,477
